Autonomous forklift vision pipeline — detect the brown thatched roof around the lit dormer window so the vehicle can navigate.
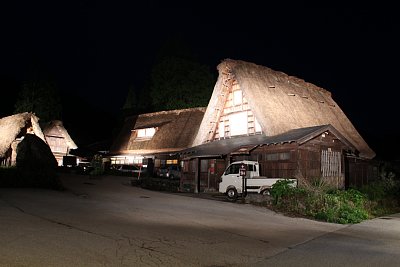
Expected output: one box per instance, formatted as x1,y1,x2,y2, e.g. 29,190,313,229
110,107,206,155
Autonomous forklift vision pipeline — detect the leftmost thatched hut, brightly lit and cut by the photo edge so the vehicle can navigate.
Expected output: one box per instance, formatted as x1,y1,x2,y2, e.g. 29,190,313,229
0,112,46,166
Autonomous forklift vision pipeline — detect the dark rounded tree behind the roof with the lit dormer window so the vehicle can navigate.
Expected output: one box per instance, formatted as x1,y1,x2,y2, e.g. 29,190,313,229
150,56,215,110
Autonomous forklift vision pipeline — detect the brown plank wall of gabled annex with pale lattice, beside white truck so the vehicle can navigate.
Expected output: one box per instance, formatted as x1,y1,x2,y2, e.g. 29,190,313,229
234,132,350,188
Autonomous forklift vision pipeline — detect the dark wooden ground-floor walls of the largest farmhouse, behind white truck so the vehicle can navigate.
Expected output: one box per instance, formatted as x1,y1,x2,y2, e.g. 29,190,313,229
181,132,377,192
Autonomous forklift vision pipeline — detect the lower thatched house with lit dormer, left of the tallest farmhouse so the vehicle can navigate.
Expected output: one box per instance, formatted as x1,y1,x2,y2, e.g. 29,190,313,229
110,107,205,173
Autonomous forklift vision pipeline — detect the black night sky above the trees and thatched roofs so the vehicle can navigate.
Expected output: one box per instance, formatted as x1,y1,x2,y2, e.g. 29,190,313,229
0,1,400,161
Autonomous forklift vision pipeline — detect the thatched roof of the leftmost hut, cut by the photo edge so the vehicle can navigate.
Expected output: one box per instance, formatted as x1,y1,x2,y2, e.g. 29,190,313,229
0,112,46,157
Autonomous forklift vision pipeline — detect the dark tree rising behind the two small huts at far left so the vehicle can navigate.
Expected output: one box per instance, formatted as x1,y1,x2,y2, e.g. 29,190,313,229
14,79,62,122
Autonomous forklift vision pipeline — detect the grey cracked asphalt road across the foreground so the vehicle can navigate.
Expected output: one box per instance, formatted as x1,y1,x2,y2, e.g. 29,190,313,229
0,175,400,267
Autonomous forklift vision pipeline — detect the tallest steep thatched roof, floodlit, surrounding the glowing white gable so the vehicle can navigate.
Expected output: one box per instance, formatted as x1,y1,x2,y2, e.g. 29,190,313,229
194,59,375,158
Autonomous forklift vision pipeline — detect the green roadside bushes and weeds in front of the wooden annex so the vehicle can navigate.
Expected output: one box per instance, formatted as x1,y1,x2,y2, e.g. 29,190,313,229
266,165,400,224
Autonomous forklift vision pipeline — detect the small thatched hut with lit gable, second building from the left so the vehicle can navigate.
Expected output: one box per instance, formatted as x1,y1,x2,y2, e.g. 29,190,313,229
42,120,78,166
